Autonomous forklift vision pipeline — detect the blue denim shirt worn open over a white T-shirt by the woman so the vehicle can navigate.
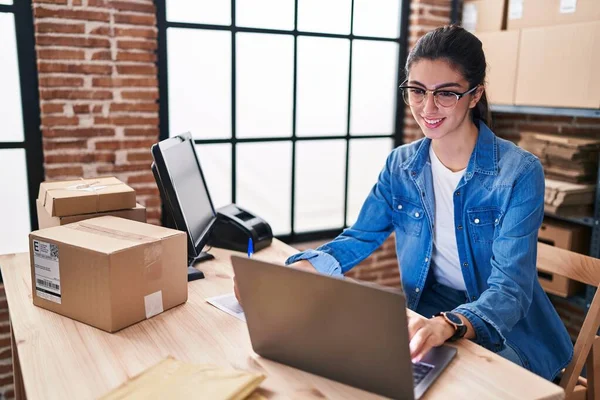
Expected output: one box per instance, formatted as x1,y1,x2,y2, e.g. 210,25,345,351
286,122,573,379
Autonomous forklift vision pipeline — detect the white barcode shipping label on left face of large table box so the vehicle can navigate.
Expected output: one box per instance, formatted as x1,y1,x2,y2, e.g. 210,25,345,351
33,239,62,304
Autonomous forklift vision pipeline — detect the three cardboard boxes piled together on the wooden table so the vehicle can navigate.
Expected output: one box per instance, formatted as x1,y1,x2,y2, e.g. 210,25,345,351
29,177,187,332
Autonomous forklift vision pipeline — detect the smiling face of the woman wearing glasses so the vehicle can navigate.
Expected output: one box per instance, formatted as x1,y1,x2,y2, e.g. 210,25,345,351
405,60,483,139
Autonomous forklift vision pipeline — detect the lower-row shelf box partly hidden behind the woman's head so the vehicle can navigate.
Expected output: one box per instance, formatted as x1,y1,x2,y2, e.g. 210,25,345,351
477,31,520,105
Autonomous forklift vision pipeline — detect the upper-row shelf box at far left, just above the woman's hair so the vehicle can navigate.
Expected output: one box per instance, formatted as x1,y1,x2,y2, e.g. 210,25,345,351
462,0,508,32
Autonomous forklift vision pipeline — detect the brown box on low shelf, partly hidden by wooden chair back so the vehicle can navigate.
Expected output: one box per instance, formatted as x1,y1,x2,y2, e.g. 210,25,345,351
538,218,590,297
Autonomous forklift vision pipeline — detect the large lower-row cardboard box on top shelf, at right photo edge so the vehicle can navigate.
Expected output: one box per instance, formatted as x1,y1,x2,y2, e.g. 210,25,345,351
515,22,600,109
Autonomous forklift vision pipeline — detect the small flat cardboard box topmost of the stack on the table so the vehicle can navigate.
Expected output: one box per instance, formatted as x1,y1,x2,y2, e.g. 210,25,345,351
38,177,136,217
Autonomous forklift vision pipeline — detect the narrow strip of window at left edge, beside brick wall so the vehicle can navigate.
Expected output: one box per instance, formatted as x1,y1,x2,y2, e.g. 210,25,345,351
0,0,44,254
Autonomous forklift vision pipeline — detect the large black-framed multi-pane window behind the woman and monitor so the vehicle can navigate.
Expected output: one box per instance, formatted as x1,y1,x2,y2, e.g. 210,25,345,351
157,0,408,242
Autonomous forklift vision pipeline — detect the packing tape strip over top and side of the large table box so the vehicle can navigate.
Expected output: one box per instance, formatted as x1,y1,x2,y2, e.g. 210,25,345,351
64,222,163,281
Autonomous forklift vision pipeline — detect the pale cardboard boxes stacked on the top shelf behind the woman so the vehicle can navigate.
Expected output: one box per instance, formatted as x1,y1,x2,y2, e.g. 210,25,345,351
463,0,600,109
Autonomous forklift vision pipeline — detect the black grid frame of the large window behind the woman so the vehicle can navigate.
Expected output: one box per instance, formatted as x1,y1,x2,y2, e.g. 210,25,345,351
155,0,410,243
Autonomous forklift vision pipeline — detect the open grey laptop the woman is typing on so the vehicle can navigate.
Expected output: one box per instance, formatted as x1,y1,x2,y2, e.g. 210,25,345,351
231,256,456,399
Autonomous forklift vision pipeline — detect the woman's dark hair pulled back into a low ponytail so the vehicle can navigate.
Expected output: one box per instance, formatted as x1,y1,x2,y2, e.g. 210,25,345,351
405,25,490,125
